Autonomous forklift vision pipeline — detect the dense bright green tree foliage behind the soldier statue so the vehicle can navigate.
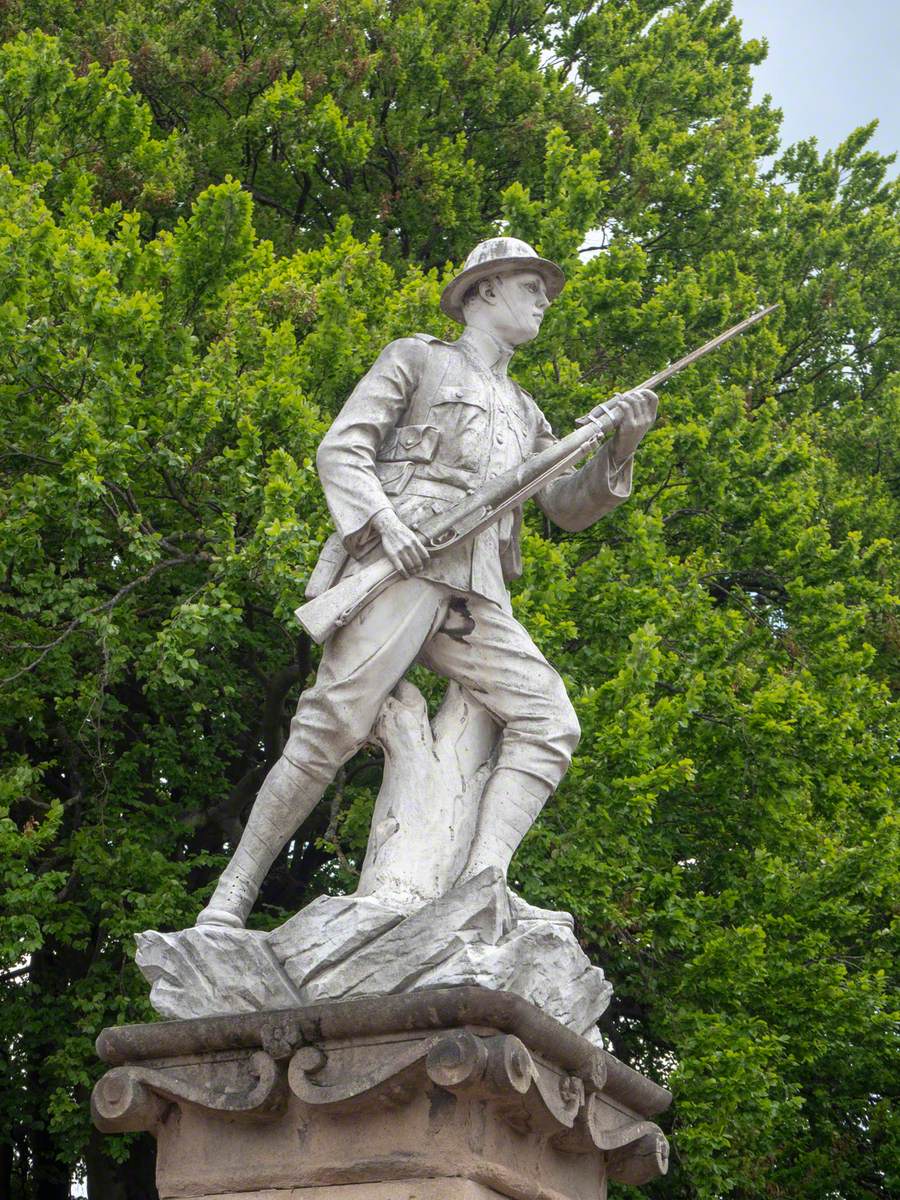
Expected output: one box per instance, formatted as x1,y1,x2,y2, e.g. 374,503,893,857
0,0,900,1200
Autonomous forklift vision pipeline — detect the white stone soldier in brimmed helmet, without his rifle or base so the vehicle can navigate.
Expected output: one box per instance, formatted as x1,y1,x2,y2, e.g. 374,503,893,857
197,238,656,928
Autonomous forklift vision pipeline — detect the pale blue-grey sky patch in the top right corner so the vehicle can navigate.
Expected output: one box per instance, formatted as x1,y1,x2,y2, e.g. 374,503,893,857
732,0,900,162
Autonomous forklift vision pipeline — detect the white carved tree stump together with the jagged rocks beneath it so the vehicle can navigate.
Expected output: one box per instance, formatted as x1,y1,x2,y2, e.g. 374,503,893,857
153,684,611,1038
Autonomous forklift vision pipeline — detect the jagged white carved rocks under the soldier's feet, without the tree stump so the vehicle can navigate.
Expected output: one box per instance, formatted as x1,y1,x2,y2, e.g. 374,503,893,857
137,871,612,1044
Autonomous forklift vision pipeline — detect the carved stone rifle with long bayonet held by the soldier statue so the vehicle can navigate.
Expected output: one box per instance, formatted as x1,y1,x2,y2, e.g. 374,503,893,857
295,304,778,642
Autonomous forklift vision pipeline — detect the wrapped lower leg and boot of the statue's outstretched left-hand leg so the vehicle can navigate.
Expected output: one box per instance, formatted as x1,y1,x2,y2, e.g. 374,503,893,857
196,758,324,929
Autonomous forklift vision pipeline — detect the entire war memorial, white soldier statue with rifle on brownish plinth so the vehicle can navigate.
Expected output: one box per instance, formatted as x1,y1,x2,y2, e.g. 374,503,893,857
92,238,770,1200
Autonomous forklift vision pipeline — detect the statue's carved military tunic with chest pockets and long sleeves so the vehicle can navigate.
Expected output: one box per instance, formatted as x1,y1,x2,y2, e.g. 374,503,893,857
307,329,631,611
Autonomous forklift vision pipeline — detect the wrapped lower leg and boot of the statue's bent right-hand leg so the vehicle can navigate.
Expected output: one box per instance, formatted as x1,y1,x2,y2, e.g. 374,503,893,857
457,767,575,929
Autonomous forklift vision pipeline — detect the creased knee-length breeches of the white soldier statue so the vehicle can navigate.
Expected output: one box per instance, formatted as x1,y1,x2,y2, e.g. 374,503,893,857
284,578,580,791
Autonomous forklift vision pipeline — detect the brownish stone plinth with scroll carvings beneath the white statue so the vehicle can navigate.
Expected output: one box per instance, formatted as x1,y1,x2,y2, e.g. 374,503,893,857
92,988,671,1200
